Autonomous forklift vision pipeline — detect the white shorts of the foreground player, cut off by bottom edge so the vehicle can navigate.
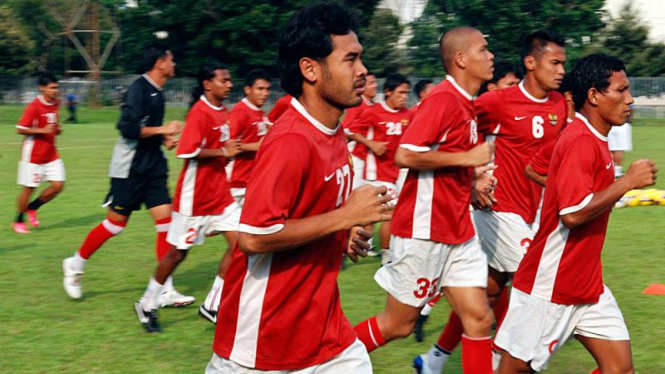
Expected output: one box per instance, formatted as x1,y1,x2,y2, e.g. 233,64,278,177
205,339,372,374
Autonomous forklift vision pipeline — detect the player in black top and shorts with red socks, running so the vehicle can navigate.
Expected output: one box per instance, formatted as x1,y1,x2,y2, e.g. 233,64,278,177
62,44,189,306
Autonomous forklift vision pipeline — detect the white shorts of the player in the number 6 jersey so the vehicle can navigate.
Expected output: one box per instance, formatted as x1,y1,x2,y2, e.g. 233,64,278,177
473,210,534,273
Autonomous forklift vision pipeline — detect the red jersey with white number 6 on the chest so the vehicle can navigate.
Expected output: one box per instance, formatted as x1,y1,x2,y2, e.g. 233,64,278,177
475,81,568,224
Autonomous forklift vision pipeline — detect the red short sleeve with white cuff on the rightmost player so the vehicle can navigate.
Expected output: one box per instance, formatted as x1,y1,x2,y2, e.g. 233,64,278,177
548,135,597,216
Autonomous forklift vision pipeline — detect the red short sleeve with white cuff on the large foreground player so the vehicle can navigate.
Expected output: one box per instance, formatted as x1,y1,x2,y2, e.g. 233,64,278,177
238,133,310,235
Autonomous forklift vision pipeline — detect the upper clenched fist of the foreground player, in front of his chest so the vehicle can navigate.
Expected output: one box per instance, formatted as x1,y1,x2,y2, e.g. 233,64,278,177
341,185,394,227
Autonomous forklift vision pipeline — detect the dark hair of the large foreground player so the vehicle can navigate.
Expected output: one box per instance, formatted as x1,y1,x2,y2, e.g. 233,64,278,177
277,1,358,97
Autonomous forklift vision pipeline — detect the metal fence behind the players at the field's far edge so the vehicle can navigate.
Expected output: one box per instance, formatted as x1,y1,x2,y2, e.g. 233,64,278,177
0,75,665,118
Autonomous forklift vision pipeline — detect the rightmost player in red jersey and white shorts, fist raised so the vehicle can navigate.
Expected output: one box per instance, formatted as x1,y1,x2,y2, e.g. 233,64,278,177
496,54,657,374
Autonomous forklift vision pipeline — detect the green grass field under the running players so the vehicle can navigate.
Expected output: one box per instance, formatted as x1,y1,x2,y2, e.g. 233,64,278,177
0,106,665,374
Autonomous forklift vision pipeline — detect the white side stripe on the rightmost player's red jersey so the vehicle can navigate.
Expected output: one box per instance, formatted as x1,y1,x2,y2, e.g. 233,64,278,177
531,220,570,301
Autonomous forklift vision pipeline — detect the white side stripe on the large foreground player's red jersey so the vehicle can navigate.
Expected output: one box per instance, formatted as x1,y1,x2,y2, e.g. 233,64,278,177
229,253,273,368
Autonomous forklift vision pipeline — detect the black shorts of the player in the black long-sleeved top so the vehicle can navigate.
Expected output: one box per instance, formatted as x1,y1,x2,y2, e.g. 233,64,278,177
104,175,171,216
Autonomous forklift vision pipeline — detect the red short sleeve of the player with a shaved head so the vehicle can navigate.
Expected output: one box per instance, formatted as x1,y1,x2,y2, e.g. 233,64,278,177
399,93,459,152
